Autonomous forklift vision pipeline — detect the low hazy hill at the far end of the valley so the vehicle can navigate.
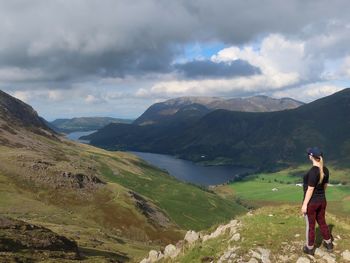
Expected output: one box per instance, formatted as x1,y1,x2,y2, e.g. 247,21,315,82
49,117,133,133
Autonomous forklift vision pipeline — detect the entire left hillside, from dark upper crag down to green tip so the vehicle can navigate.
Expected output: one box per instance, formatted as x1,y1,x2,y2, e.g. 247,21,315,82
0,90,246,262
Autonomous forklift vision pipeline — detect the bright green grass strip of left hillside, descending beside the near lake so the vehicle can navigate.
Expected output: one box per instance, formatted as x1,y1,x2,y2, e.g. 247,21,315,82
98,151,245,230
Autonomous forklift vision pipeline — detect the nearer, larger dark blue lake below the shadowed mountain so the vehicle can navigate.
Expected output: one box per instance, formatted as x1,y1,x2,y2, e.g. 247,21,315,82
131,152,254,186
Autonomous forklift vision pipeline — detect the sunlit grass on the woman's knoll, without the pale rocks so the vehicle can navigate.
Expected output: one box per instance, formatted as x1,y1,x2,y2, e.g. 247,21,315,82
163,205,350,263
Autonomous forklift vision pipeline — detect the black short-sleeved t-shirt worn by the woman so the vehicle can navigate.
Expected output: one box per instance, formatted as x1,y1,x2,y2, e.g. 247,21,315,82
303,166,329,202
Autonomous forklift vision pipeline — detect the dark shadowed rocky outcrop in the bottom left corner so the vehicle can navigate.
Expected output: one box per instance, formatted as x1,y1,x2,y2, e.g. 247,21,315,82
0,216,79,262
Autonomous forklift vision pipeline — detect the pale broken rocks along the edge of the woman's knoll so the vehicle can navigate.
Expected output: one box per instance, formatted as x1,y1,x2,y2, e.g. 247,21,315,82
141,210,350,263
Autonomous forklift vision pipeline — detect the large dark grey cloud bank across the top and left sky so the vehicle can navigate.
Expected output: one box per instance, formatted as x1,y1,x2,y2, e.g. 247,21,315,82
0,0,350,86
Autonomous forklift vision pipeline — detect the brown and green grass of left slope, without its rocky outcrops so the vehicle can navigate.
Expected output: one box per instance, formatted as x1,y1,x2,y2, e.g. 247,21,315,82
0,134,245,262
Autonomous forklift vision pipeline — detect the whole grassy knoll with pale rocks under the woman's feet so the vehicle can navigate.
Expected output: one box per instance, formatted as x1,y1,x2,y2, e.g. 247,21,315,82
141,205,350,263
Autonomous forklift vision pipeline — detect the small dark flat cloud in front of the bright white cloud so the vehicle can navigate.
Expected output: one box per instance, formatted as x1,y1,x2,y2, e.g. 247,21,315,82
174,60,261,79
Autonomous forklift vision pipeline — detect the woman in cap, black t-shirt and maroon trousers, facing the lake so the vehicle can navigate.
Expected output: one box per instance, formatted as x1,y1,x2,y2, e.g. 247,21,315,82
301,147,333,255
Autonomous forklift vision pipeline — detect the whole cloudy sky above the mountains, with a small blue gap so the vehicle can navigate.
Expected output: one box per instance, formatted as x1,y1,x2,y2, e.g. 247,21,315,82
0,0,350,120
